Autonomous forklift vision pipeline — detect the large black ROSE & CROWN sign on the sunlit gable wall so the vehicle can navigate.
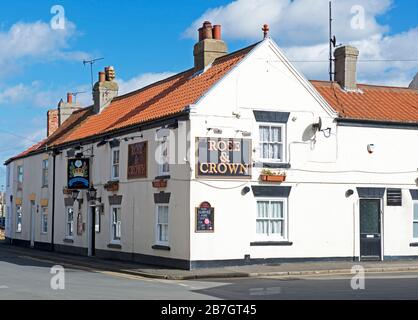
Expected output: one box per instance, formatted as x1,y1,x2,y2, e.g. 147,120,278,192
196,138,252,178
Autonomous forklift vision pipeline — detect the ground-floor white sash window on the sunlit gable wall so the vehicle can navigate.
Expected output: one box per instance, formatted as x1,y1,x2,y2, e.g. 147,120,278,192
256,199,287,240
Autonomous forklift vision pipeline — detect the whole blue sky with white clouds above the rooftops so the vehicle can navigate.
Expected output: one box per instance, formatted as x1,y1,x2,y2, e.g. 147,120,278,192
0,0,418,188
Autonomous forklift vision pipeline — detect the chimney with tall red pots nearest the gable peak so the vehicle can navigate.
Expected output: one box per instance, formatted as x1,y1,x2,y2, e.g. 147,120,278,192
193,21,228,70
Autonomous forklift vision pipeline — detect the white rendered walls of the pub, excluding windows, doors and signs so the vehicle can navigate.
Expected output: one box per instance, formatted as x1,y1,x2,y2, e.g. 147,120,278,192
6,39,418,268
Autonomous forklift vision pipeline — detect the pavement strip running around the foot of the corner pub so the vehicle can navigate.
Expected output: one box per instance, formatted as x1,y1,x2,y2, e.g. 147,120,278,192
0,242,418,280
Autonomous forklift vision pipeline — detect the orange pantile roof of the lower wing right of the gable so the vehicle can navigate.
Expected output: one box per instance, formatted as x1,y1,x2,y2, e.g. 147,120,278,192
311,81,418,123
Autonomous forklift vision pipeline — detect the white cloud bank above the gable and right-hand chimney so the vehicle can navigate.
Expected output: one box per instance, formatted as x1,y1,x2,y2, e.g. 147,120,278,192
184,0,418,85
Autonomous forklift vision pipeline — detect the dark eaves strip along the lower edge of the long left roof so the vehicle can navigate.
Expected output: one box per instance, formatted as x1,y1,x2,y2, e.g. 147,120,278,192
4,107,190,165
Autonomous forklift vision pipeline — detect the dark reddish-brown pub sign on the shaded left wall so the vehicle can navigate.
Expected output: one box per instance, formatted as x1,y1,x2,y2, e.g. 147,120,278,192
128,141,148,179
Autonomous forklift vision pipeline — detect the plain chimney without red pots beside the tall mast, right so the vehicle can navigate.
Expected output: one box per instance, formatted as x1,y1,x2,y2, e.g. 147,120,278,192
334,46,359,91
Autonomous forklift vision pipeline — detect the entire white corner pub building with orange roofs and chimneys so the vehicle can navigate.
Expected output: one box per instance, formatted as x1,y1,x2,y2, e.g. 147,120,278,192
6,22,418,269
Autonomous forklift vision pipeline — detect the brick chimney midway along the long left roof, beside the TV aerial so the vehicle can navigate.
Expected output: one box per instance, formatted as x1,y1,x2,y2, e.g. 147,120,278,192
93,67,119,113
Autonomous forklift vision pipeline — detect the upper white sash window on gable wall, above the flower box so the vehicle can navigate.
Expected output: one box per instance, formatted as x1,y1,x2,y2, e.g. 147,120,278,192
259,125,285,162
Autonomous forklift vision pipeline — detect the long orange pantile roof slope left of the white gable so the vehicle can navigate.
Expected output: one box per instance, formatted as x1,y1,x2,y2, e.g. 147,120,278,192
7,44,257,162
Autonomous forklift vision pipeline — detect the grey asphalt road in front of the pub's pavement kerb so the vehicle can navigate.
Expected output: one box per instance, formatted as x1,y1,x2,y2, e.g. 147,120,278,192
0,248,418,300
